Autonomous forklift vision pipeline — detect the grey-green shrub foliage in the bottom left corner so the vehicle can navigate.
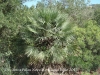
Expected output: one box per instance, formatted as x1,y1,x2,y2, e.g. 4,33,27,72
0,52,13,75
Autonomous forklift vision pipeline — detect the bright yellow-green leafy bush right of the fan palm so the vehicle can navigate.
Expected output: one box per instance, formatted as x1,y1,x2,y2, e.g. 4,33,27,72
69,20,100,69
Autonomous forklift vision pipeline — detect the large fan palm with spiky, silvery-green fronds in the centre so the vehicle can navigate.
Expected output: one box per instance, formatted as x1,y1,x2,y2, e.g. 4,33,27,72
24,8,72,66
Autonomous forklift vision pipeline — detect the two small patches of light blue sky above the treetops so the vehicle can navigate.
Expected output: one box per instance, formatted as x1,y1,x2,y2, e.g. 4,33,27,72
24,0,100,7
